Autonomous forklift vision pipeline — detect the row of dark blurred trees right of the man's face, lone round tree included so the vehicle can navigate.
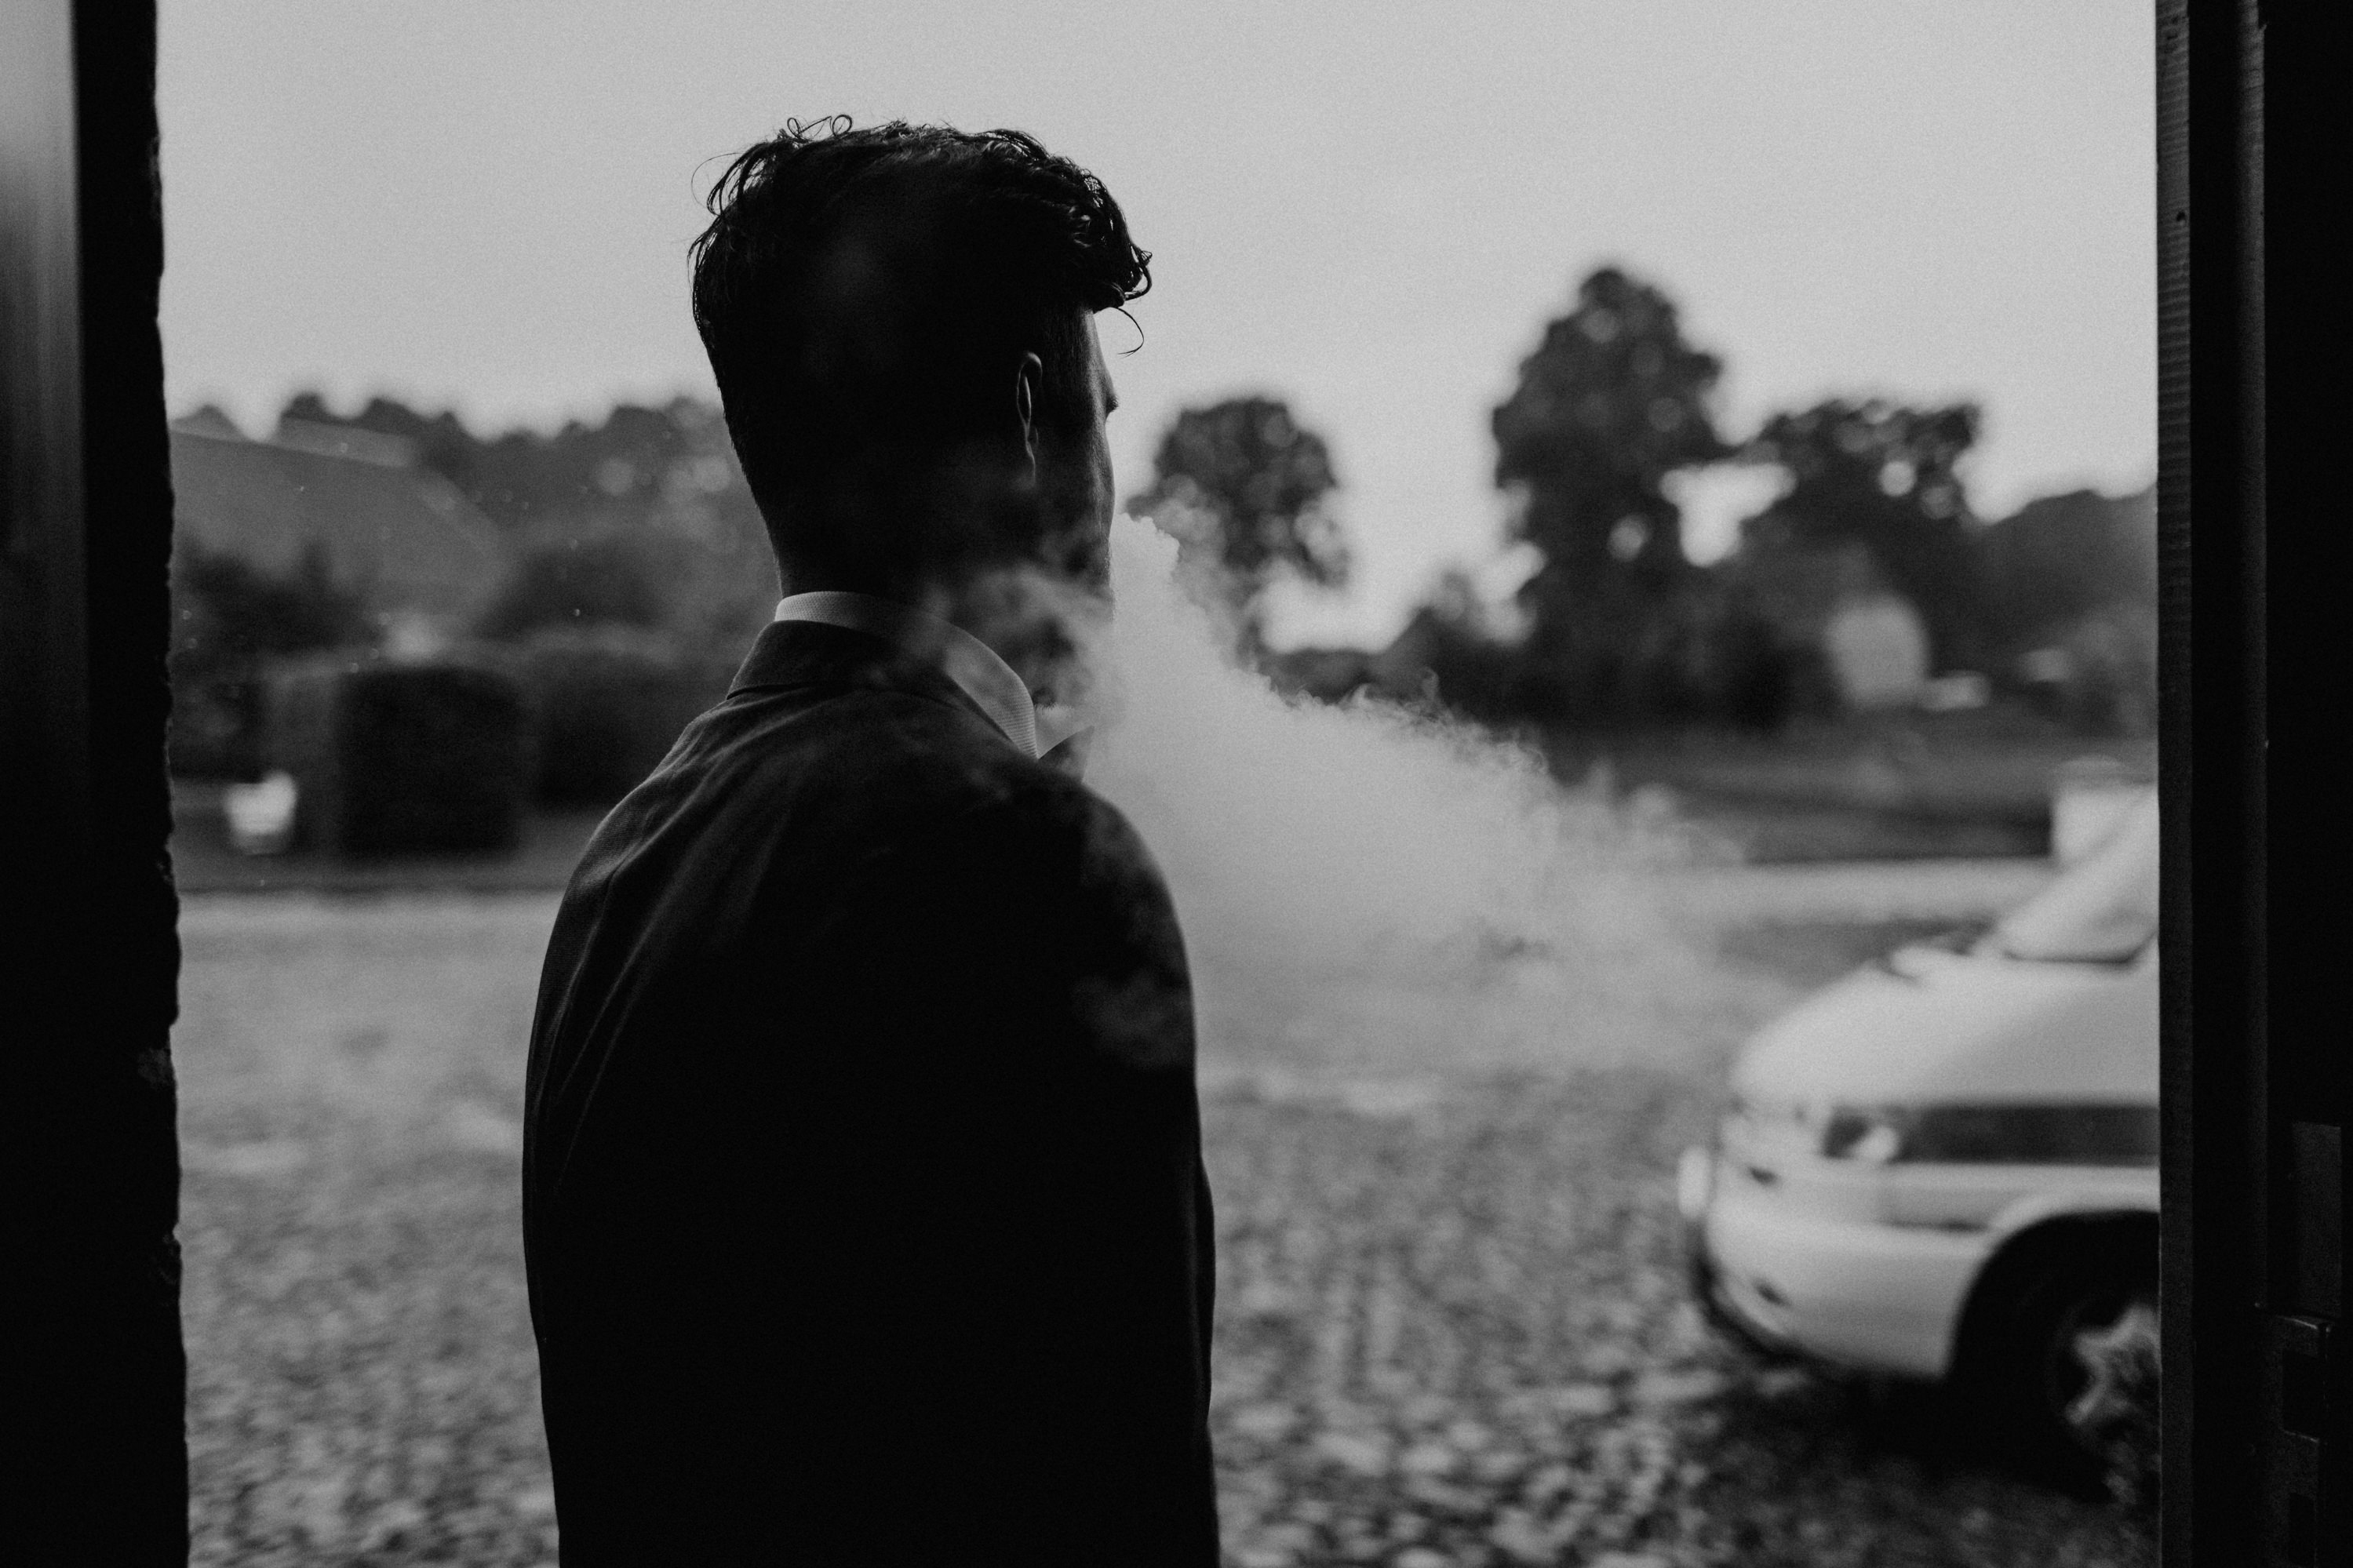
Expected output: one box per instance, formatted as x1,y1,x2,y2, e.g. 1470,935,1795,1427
1135,268,2155,729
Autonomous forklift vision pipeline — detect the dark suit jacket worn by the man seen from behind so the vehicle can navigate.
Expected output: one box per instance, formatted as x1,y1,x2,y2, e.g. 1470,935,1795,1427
525,623,1216,1568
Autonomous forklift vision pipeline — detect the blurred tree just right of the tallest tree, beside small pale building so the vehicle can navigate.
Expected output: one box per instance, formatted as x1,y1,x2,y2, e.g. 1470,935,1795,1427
1741,397,1988,670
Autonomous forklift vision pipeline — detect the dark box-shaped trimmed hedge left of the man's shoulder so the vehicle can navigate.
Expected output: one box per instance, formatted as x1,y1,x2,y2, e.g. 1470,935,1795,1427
264,656,532,856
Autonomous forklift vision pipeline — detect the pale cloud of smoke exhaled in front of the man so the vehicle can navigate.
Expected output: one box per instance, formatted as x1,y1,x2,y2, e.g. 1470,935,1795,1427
1087,519,1725,1072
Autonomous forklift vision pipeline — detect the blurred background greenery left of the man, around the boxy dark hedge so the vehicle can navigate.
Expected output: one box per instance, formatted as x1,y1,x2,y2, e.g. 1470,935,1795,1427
172,392,777,806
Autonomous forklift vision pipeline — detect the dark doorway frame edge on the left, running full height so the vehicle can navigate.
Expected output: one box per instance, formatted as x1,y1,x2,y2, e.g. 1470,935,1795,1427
0,0,188,1563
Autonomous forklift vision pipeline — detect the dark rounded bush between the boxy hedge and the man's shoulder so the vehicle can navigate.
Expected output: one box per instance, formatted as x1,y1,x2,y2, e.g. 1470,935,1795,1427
511,625,727,806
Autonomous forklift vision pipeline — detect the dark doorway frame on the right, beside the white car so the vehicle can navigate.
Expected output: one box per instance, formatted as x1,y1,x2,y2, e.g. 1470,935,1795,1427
2158,0,2353,1568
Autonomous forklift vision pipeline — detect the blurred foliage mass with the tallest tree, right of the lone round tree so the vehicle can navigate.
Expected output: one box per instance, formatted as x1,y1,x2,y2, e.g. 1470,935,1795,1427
1261,266,2155,757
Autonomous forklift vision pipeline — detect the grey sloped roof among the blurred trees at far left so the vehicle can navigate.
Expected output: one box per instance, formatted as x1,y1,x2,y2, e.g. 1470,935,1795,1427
172,425,506,625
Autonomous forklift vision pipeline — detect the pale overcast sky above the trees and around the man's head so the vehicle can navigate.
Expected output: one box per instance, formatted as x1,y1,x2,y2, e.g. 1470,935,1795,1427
160,0,2155,639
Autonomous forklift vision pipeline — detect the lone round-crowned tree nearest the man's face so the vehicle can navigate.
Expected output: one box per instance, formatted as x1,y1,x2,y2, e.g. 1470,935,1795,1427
1127,397,1348,660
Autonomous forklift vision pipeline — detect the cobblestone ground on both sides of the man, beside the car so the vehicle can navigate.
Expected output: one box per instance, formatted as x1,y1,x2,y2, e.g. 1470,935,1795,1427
179,898,2153,1568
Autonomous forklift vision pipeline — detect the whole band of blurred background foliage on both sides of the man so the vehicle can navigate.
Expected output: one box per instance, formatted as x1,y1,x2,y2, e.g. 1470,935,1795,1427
172,266,2155,822
